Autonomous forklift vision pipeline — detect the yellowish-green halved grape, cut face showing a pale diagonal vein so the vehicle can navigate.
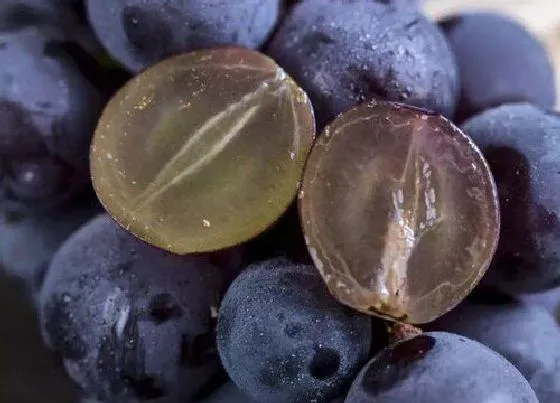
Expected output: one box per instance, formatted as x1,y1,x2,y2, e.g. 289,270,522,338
90,47,315,254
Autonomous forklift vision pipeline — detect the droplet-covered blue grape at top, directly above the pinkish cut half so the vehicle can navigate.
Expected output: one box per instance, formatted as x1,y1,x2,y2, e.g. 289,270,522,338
268,0,459,127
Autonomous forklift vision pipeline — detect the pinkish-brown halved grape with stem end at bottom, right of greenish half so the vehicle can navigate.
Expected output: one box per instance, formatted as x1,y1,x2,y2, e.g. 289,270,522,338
299,102,499,324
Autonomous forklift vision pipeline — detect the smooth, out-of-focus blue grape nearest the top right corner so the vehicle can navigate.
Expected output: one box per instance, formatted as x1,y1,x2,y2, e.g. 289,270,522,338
440,13,556,119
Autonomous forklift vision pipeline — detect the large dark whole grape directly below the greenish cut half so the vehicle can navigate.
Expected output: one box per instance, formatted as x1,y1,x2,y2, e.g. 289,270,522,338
40,214,220,402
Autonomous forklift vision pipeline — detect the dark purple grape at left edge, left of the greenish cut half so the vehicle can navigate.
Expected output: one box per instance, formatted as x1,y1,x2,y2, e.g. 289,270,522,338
0,25,102,215
